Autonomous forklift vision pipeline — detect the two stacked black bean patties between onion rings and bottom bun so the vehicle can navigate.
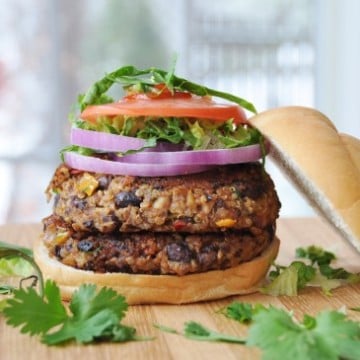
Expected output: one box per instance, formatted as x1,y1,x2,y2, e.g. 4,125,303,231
43,163,280,275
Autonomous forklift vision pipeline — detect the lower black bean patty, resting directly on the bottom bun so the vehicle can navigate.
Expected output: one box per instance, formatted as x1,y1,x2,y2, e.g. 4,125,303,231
43,215,275,275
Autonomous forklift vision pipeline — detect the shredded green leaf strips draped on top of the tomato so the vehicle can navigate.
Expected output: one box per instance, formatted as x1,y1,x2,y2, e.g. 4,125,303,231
78,65,256,113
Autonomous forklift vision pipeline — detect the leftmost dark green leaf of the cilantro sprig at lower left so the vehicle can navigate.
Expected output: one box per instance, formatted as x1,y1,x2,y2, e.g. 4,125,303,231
3,281,67,335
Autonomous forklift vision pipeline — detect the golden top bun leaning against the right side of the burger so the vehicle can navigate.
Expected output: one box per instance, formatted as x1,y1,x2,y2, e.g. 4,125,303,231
249,106,360,251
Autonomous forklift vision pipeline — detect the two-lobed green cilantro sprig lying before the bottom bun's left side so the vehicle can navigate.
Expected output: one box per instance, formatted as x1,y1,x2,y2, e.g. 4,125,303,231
3,280,139,345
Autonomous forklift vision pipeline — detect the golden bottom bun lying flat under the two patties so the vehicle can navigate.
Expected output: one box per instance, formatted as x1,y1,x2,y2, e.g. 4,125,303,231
34,238,280,305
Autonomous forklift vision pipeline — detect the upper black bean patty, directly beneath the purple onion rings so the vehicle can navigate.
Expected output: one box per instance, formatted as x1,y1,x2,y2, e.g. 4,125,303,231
47,163,280,233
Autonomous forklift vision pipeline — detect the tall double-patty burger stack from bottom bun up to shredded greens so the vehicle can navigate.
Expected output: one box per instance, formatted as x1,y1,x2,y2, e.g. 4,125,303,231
34,66,359,304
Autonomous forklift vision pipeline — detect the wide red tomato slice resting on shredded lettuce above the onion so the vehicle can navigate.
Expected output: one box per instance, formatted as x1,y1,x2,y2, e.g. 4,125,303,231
80,96,246,124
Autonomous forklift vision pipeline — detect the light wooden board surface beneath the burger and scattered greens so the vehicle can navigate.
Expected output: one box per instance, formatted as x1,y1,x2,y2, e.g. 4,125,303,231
0,218,360,360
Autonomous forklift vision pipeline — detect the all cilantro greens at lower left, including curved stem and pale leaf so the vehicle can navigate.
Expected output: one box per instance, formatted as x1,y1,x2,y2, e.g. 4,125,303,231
0,242,150,345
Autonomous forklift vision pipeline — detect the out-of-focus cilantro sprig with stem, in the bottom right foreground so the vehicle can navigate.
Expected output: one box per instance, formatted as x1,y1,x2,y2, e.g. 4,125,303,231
156,301,360,360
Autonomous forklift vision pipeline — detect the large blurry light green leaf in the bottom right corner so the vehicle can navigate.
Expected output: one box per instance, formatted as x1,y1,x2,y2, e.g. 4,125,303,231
247,307,360,360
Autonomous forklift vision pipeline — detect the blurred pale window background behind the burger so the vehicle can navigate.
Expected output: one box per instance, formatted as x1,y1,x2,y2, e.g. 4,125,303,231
0,0,360,224
